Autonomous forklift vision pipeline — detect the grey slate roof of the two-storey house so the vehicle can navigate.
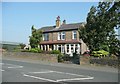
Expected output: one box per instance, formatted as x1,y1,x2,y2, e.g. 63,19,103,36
38,22,85,33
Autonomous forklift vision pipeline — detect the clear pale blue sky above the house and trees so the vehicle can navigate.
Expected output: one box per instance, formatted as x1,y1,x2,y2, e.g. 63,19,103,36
2,2,98,44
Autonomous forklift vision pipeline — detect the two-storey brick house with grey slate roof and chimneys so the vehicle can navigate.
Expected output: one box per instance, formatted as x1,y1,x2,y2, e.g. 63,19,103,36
40,16,87,55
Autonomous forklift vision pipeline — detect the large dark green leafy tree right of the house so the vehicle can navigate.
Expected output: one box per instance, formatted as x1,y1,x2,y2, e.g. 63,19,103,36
79,1,120,56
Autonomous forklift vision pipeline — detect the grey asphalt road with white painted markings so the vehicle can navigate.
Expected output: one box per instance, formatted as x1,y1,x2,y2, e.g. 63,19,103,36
0,60,118,83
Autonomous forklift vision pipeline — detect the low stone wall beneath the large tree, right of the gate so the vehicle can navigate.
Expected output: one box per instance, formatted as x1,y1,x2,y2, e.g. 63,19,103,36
80,56,120,68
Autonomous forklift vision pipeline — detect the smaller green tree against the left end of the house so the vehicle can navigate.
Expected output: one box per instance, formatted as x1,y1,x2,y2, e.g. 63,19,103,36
29,25,42,48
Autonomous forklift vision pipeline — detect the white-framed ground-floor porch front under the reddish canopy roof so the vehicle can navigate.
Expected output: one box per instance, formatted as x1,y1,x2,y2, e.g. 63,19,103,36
40,43,81,56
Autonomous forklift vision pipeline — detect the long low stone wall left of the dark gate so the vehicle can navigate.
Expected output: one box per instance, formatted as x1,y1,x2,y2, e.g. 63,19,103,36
2,52,58,63
